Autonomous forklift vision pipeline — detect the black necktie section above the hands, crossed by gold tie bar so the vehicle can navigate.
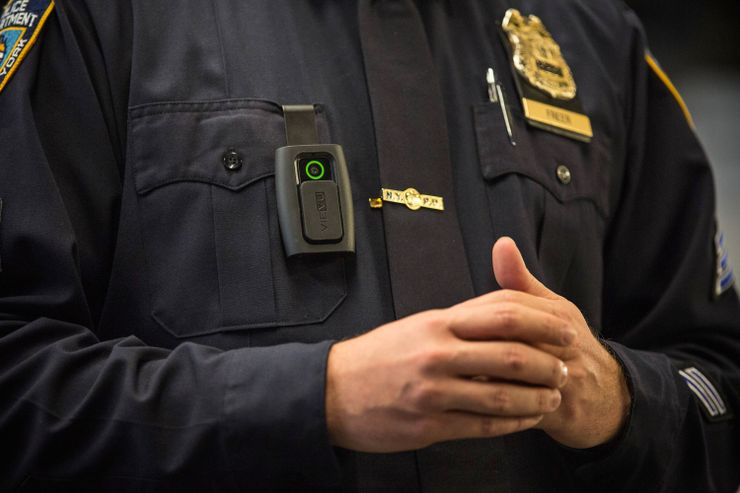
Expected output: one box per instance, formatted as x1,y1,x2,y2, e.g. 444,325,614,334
359,0,473,318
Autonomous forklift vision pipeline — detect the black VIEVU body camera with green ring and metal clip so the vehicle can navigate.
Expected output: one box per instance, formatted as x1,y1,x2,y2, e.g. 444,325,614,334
275,105,355,257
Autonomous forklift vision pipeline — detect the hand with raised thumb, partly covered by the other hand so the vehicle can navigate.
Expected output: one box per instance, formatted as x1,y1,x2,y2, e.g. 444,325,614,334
488,238,631,448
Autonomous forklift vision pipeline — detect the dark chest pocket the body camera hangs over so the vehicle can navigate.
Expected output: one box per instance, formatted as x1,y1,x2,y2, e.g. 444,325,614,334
129,100,346,337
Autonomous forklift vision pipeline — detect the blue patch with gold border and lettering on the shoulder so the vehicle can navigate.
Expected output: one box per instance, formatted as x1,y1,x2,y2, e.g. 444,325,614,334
0,0,54,92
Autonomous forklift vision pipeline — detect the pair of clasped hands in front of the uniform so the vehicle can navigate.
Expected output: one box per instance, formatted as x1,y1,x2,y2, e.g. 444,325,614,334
326,238,630,452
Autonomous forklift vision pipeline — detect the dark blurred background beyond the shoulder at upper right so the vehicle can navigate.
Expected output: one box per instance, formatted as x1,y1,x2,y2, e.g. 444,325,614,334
626,0,740,262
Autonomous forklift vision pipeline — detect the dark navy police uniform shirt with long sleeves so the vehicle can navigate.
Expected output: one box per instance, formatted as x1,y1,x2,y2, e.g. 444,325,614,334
0,0,740,492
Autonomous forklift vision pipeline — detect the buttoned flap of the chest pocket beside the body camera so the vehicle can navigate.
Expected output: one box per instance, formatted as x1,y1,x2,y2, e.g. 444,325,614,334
130,100,285,194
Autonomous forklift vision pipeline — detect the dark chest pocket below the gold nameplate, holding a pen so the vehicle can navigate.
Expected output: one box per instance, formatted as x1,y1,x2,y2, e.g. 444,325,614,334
474,104,611,304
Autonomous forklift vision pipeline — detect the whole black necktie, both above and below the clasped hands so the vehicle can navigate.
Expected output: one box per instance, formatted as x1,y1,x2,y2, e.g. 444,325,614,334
355,0,503,492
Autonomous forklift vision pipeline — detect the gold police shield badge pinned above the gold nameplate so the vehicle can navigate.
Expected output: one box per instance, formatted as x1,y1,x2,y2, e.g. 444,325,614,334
501,9,576,101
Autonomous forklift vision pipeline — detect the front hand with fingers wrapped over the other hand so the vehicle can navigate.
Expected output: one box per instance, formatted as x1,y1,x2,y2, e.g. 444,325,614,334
326,288,576,452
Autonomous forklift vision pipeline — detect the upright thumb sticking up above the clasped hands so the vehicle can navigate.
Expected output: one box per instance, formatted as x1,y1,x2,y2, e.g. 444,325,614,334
491,236,559,298
